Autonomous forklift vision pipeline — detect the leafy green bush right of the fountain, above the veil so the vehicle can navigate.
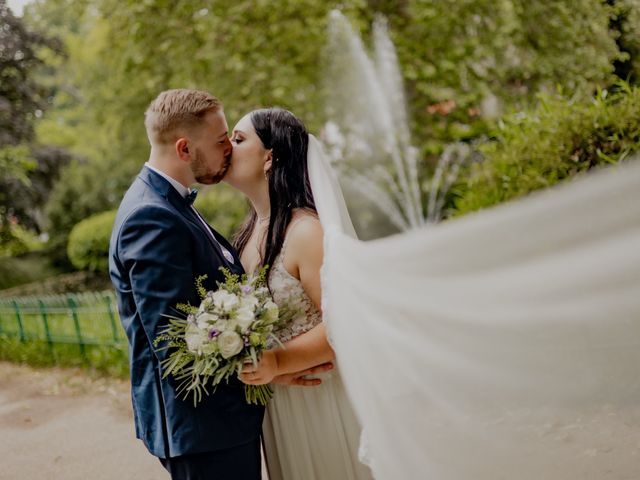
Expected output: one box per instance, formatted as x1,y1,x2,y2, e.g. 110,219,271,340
452,84,640,215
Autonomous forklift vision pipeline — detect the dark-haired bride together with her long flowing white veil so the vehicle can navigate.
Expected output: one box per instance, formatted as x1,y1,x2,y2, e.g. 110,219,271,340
227,109,640,480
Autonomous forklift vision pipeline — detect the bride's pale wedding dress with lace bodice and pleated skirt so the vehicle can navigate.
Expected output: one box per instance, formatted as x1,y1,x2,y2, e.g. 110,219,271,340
263,227,372,480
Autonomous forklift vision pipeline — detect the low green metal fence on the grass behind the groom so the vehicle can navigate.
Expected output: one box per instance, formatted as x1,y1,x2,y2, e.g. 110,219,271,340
0,291,127,356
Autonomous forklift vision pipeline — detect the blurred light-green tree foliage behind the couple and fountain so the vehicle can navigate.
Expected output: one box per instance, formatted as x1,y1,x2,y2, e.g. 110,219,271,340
20,0,638,258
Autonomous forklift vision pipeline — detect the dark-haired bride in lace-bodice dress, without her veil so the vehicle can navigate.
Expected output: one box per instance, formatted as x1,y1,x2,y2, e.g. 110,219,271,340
224,108,372,480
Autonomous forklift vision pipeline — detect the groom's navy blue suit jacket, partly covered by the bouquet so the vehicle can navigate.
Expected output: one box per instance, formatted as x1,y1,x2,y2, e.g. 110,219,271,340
109,167,264,458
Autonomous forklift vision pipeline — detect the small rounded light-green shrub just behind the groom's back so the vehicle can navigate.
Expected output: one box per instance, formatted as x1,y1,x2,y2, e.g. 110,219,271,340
67,210,116,272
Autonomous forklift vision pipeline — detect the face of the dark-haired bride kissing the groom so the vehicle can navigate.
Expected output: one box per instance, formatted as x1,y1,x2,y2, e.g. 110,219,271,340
224,114,271,191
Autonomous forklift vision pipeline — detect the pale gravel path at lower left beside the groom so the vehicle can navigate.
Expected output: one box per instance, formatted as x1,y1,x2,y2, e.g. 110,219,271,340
0,362,266,480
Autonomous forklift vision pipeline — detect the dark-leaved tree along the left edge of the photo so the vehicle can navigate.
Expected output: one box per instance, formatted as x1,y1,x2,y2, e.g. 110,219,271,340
0,0,68,251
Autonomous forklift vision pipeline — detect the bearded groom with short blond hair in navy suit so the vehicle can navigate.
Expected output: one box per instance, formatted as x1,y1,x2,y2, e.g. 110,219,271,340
109,90,323,480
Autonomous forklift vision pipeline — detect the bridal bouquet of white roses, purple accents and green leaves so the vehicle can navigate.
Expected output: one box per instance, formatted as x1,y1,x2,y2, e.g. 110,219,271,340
154,267,281,405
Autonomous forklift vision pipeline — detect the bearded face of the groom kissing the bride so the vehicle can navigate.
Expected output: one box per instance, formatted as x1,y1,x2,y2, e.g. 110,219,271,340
191,110,232,185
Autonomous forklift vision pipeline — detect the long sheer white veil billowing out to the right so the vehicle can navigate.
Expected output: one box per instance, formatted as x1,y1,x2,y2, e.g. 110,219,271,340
309,138,640,480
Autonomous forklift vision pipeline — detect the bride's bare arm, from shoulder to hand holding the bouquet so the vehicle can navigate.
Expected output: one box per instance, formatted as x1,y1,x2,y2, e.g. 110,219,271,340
241,217,335,385
